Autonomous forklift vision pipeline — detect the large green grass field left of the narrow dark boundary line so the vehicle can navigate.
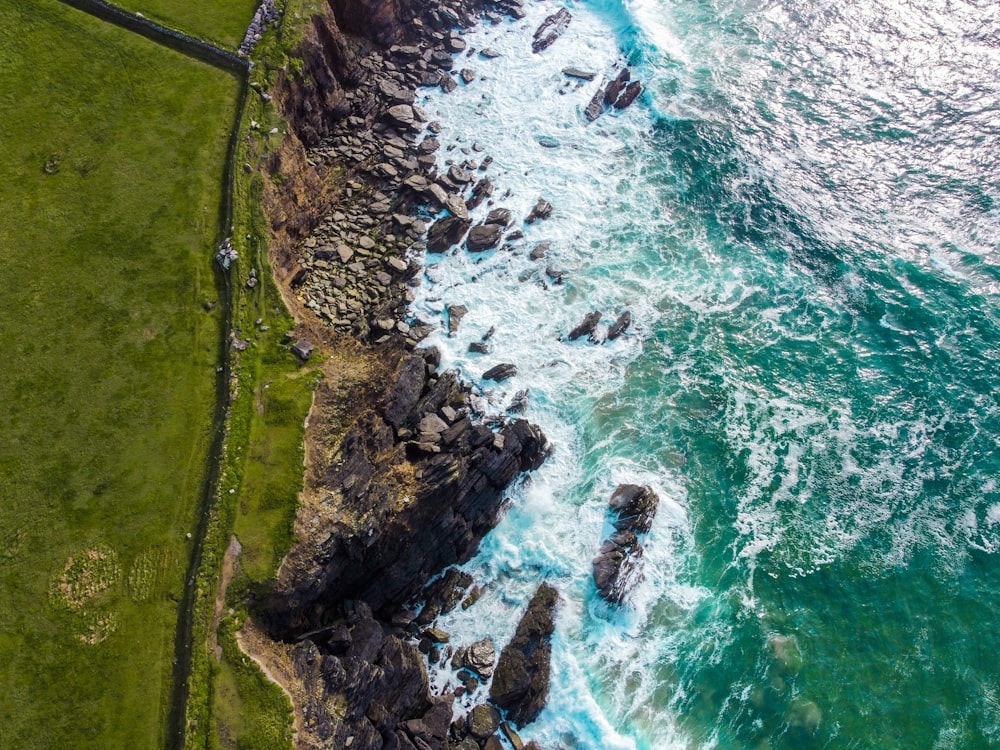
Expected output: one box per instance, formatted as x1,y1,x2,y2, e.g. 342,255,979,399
0,0,238,750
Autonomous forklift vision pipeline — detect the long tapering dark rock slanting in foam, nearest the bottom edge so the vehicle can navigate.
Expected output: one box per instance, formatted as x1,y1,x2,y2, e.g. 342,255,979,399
490,583,559,727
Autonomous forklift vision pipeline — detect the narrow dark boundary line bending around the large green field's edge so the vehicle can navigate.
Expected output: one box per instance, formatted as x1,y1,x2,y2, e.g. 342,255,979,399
53,0,250,750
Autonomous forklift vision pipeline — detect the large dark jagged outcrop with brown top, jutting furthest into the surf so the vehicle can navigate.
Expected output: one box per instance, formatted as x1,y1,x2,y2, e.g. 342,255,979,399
268,352,547,639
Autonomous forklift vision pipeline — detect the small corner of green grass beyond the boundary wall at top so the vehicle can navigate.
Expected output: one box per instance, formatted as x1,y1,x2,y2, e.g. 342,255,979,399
109,0,260,50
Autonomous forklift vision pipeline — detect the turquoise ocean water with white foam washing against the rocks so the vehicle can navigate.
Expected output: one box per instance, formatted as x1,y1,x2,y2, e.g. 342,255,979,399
406,0,1000,750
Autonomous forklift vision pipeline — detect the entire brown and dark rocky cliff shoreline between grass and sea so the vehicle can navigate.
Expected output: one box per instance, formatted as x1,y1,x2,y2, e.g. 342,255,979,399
241,0,568,750
